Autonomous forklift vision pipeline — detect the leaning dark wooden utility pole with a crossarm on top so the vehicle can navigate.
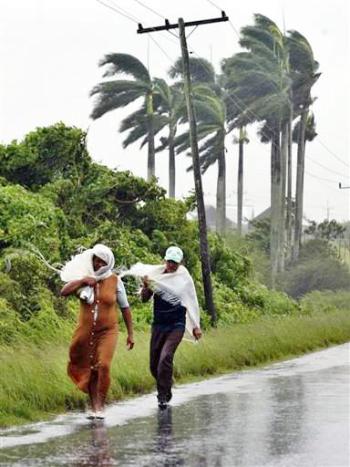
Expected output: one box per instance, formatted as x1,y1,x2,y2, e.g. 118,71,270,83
137,11,228,324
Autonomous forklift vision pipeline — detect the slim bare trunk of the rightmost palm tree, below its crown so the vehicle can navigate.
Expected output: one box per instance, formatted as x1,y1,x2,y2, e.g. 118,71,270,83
293,108,308,261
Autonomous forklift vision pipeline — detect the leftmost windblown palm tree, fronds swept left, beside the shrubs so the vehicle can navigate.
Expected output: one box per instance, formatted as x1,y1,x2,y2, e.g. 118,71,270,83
91,53,155,180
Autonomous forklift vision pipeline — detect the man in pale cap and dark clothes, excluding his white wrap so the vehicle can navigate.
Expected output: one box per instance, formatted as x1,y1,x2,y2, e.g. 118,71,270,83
141,247,202,409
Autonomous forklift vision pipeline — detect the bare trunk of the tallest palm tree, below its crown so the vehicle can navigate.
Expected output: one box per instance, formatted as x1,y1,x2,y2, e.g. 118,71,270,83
270,128,281,287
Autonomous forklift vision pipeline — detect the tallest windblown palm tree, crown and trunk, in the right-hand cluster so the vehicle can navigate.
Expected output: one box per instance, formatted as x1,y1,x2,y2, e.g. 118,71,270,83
223,15,291,282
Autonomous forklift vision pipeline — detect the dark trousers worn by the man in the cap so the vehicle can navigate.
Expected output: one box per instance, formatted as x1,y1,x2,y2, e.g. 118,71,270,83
150,327,184,397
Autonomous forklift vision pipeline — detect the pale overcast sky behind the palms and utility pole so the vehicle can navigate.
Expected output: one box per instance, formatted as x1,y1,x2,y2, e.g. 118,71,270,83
0,0,350,221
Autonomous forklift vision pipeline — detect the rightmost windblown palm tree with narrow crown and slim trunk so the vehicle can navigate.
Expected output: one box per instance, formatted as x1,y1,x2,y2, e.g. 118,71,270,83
287,31,321,260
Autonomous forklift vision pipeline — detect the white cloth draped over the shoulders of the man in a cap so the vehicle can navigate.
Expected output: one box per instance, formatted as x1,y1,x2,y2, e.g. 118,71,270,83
122,263,200,340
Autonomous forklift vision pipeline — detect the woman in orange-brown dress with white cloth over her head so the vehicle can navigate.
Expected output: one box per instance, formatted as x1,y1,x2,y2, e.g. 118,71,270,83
61,245,134,418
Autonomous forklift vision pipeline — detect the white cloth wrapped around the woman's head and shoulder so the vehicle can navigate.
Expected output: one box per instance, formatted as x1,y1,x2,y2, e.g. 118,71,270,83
60,244,114,305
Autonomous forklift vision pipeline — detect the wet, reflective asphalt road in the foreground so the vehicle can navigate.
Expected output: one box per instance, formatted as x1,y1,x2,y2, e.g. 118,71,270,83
0,344,350,467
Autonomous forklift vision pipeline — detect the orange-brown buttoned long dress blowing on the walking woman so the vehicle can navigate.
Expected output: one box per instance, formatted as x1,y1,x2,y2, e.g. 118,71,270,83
68,274,118,400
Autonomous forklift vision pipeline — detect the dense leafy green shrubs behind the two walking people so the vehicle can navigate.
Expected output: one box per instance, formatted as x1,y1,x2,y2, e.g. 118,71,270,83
0,124,306,339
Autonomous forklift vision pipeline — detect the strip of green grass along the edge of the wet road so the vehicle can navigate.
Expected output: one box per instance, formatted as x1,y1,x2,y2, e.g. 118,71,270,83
0,310,350,427
